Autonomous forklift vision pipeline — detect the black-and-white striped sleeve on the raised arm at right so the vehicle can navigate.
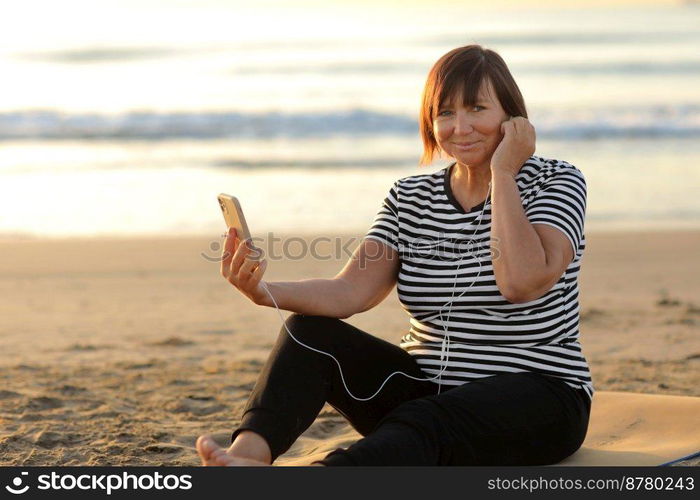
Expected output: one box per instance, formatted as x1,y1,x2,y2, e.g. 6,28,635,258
525,164,586,256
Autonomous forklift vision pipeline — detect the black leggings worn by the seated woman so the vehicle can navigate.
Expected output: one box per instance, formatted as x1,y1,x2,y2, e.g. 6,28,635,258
232,314,591,466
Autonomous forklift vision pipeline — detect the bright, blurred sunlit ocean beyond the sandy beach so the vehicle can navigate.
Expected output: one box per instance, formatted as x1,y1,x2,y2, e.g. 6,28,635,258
0,0,700,238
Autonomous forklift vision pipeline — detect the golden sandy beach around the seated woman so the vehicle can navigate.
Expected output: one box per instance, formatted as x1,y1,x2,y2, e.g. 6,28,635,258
0,231,700,465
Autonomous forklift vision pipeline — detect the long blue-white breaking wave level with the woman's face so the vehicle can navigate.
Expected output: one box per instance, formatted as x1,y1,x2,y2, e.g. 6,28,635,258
0,104,700,141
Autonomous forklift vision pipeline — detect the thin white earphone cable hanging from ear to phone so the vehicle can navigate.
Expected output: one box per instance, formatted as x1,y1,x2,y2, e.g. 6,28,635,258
260,182,491,401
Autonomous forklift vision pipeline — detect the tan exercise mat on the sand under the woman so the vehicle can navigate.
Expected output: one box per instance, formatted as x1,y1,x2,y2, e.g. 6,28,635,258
275,391,700,466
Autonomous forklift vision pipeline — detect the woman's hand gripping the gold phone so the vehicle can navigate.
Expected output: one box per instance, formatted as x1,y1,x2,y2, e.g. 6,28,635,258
221,228,271,305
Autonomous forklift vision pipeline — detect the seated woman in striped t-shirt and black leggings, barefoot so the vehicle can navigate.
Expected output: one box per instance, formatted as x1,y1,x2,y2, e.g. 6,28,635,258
197,45,593,466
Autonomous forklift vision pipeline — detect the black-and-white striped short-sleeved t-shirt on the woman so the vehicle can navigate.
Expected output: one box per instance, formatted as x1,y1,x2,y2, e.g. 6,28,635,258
365,156,594,398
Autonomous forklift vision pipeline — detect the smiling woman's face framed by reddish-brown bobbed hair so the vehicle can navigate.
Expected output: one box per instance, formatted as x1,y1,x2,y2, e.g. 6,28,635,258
433,80,509,168
